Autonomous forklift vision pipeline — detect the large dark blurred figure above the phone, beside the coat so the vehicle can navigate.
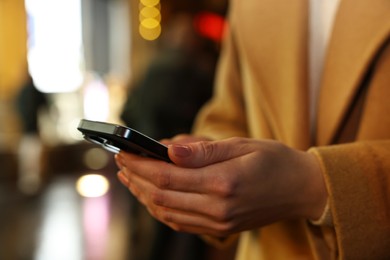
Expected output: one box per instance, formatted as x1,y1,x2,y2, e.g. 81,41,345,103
122,14,217,139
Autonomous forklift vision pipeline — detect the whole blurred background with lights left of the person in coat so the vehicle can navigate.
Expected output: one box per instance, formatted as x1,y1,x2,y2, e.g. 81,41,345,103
0,0,235,260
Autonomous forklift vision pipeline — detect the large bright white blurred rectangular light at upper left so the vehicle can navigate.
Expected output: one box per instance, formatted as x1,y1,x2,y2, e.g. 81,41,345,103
25,0,83,93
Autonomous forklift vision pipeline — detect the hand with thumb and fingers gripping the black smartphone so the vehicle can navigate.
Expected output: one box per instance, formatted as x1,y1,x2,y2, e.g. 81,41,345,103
117,138,327,237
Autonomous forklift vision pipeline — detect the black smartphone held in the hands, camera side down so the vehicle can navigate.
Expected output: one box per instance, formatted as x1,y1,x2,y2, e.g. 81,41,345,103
77,119,171,162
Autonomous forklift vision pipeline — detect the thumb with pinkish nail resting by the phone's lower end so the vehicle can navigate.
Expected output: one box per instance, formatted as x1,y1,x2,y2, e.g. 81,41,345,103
168,140,247,168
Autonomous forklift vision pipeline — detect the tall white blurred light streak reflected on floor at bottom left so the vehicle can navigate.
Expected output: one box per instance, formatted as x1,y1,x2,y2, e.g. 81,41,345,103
32,179,84,260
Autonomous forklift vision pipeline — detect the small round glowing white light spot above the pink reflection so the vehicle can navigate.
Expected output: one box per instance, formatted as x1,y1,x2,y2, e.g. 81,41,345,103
76,174,110,198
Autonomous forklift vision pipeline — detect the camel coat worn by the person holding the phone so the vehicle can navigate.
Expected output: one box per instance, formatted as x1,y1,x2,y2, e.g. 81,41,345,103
194,0,390,260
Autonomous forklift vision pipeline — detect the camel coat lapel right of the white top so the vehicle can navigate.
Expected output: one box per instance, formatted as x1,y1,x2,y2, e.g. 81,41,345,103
317,0,390,145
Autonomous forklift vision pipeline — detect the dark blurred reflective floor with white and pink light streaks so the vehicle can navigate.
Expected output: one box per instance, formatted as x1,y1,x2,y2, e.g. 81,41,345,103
0,143,238,260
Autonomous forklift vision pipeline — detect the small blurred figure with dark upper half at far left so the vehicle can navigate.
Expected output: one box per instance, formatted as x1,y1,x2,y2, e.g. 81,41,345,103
16,74,48,194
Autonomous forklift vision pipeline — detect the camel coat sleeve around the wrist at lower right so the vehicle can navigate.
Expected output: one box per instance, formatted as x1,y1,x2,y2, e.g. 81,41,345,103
310,140,390,259
